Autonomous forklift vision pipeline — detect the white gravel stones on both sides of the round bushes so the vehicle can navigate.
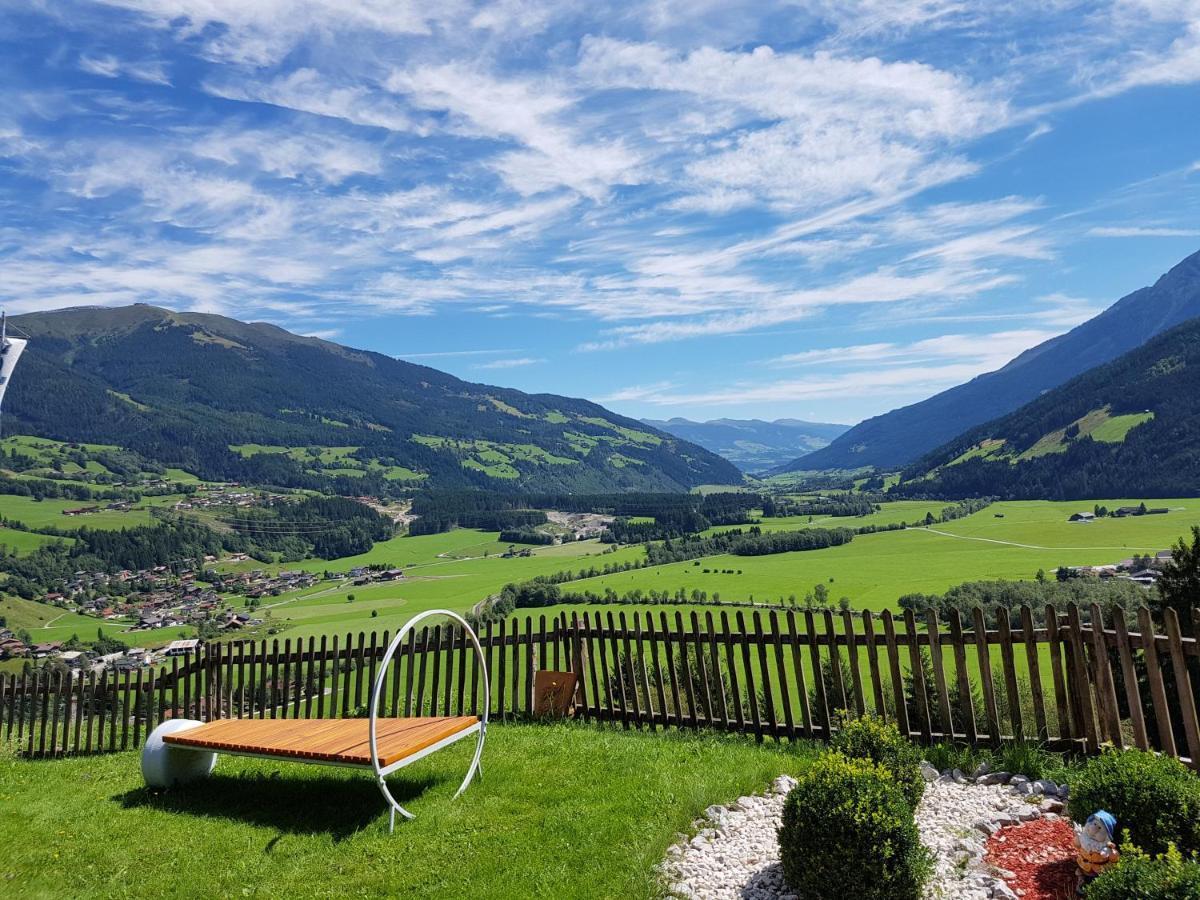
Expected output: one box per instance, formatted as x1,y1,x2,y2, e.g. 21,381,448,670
661,763,1067,900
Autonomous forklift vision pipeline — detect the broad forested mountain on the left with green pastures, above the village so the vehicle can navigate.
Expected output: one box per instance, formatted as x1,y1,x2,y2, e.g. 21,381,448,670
5,305,742,493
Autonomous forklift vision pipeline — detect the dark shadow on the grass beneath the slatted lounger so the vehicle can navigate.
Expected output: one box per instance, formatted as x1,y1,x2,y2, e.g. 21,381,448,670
113,774,445,851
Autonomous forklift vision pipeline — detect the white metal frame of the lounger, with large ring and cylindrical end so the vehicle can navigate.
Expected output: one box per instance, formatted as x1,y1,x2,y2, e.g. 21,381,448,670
142,610,492,834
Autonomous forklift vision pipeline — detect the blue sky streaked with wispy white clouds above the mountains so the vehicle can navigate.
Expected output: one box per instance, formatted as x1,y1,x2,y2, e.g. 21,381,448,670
0,0,1200,422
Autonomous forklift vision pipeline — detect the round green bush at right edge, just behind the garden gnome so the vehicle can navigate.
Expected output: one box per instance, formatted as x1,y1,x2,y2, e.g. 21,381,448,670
1070,750,1200,853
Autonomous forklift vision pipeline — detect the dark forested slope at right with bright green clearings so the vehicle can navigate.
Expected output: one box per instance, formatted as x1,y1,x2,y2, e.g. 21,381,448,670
896,318,1200,499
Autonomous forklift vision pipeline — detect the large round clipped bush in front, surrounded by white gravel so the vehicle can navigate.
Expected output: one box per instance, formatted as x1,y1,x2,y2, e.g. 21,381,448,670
779,752,932,900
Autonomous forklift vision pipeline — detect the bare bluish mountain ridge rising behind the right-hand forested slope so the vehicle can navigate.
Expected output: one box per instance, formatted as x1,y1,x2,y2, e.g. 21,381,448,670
780,252,1200,472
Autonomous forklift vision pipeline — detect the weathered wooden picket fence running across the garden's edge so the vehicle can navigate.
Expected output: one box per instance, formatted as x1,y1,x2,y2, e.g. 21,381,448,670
0,606,1200,766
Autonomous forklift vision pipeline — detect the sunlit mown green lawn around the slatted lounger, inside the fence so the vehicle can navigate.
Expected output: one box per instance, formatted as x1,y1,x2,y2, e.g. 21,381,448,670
0,725,811,898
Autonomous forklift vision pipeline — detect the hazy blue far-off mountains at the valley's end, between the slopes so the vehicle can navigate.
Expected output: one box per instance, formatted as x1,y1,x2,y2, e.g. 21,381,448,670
642,418,850,472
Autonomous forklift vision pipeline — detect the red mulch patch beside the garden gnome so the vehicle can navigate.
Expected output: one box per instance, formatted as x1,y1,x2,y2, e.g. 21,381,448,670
984,818,1076,900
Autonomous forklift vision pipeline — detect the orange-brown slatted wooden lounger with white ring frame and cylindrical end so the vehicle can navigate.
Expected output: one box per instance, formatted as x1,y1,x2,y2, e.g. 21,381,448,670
142,610,491,830
